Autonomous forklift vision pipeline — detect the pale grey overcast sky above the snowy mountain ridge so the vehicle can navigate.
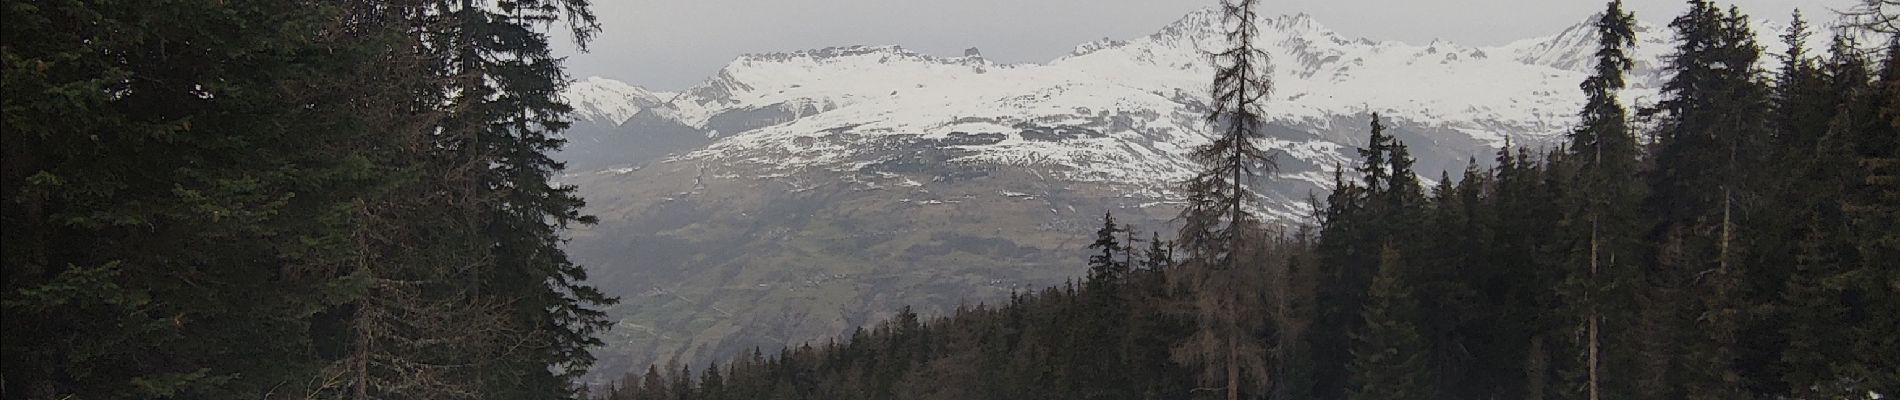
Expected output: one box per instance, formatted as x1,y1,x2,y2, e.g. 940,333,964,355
557,0,1858,91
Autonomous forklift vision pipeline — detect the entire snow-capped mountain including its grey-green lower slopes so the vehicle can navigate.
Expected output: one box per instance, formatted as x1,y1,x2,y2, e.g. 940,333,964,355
568,9,1820,379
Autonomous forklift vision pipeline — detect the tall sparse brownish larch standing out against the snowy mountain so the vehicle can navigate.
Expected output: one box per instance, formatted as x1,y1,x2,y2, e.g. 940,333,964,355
1169,0,1273,400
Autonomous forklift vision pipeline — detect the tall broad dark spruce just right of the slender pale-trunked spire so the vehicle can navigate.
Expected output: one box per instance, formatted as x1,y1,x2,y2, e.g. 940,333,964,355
1640,0,1769,398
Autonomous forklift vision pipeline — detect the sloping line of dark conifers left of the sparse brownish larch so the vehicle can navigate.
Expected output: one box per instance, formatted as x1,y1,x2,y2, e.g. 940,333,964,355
595,216,1311,400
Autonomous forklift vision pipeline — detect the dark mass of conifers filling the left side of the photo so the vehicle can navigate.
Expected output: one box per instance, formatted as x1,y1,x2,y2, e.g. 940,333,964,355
0,0,612,398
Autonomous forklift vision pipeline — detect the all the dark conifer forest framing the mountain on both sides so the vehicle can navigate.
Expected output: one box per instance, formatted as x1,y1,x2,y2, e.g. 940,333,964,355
0,0,1900,400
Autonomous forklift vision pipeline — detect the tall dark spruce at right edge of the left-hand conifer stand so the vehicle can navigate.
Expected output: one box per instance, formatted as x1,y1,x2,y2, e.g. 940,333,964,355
412,0,611,398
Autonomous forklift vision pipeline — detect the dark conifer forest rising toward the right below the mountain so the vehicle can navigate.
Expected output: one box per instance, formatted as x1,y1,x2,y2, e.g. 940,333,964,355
597,0,1900,400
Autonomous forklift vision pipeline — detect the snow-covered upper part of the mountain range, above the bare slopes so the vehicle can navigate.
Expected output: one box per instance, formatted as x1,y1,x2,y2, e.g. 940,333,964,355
576,9,1824,206
